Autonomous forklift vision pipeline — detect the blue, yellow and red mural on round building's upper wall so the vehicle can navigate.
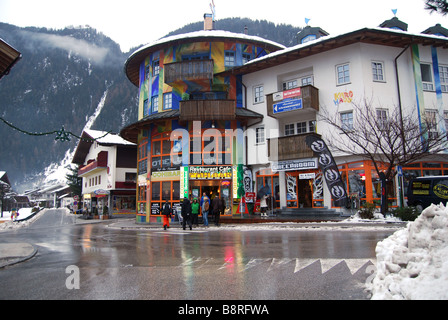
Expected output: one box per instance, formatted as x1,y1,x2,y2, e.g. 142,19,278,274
139,42,269,120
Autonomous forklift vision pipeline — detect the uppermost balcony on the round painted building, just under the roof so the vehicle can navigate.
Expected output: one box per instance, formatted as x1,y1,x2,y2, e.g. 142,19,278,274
164,60,213,84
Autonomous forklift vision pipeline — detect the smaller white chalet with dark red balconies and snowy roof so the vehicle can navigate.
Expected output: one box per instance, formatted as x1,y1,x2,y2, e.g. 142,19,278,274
72,130,137,218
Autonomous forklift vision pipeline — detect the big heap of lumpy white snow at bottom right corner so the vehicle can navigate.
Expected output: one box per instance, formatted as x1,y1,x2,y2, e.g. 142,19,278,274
372,204,448,300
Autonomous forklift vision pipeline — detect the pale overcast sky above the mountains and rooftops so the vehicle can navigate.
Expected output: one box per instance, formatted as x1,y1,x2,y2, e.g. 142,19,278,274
0,0,448,52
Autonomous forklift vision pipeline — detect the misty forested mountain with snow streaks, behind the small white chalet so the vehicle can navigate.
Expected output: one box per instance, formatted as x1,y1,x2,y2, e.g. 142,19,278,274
0,23,137,192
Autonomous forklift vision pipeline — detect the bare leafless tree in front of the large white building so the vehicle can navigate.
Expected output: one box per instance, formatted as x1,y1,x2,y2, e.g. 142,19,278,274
320,100,447,213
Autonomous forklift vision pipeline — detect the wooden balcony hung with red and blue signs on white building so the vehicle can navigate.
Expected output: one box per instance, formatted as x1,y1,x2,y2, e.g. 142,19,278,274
266,85,319,118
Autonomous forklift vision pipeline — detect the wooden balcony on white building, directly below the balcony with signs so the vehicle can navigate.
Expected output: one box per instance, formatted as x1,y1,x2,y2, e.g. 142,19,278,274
268,132,316,161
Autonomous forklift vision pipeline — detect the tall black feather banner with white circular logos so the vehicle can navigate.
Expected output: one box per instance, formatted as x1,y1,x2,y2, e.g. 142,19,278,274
306,135,348,207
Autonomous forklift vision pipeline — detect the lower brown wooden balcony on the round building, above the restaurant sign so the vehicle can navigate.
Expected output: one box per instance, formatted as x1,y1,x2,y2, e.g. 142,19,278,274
179,100,236,121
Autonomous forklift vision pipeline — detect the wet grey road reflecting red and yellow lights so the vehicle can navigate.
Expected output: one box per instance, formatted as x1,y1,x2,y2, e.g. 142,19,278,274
0,210,395,300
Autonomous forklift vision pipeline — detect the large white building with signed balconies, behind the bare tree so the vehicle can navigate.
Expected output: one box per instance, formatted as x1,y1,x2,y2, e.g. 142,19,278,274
233,18,448,209
